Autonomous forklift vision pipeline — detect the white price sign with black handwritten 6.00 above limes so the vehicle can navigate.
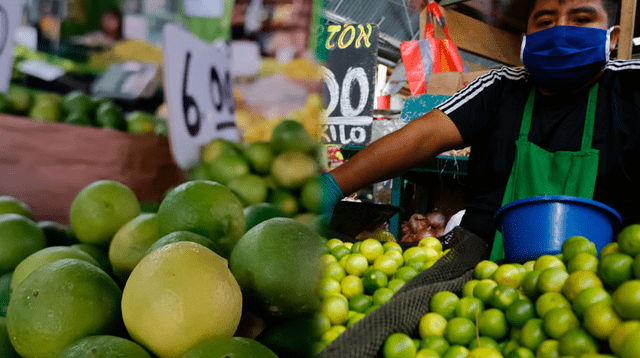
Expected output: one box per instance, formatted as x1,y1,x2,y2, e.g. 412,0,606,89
164,24,239,169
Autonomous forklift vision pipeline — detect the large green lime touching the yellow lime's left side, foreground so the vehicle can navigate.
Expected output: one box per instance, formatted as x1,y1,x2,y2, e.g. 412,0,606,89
7,259,122,358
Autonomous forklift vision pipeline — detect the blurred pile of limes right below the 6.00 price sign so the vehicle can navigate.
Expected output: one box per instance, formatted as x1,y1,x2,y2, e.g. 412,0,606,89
189,120,322,228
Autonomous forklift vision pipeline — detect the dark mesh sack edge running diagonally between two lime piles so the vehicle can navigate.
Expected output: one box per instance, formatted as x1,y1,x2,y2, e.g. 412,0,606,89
318,226,488,358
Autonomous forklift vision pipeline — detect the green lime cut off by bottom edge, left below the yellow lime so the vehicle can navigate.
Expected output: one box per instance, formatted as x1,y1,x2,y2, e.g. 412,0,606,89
56,336,151,358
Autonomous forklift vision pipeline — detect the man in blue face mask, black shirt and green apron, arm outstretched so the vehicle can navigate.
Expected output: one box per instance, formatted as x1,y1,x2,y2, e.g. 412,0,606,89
323,0,640,260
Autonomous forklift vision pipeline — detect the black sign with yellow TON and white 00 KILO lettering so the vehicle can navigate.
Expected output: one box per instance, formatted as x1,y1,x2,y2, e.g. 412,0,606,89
319,24,379,145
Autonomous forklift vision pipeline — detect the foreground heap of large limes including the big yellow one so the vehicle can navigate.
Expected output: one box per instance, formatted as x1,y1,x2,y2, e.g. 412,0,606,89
0,174,324,358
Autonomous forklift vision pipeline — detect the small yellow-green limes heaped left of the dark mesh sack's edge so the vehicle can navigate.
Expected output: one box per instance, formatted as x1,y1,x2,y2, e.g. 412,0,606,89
315,234,448,351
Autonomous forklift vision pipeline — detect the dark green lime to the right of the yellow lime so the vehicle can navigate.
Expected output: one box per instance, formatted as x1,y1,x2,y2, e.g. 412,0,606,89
229,218,324,315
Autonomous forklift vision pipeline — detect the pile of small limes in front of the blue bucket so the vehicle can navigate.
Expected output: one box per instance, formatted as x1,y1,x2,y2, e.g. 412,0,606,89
372,232,640,358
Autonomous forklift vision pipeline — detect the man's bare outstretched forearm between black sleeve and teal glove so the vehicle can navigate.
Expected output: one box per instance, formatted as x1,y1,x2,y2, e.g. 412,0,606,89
331,109,464,195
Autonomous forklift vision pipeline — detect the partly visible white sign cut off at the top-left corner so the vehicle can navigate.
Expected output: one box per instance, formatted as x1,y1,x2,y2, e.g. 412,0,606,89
0,0,24,93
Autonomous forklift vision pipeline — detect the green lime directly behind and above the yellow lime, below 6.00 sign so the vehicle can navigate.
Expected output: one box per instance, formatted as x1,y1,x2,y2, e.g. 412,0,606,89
158,180,246,258
